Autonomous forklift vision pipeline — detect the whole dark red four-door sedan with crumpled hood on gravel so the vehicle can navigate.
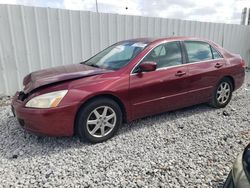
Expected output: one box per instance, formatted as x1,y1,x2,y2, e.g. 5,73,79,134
12,37,245,142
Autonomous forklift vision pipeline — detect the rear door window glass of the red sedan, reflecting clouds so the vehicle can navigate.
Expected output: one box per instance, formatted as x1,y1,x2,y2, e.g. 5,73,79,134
184,41,213,63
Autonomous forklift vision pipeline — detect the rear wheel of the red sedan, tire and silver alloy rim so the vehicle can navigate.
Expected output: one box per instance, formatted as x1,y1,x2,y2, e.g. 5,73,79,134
209,77,233,108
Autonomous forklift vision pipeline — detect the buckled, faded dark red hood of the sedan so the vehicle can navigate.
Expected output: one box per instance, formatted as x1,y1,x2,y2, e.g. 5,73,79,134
23,64,111,94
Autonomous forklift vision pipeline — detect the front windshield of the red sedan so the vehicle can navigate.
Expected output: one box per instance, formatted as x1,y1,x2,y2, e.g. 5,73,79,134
84,41,147,70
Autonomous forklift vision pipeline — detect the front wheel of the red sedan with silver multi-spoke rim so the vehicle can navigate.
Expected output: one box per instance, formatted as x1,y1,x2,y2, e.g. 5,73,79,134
76,97,122,143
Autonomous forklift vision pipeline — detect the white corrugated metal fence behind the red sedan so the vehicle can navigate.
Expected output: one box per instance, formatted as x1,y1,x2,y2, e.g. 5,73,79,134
0,5,250,95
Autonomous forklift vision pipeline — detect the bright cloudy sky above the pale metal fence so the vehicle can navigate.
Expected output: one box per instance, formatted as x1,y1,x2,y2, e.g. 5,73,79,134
0,0,250,24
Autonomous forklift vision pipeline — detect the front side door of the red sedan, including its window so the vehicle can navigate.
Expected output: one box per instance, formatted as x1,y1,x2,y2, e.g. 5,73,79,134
129,42,190,118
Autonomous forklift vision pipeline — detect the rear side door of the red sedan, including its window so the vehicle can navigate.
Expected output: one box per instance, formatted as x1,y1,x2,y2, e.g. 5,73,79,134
184,41,225,104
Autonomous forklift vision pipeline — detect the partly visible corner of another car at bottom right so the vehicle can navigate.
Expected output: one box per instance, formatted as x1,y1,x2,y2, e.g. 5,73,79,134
223,143,250,188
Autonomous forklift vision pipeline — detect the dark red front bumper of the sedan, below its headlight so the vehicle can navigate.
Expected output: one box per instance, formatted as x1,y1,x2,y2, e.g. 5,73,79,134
11,93,77,136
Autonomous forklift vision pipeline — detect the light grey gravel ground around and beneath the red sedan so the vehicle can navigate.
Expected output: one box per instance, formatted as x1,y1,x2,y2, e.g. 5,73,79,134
0,73,250,187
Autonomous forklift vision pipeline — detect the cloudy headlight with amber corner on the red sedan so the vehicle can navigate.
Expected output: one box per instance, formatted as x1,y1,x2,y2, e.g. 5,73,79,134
25,90,68,108
